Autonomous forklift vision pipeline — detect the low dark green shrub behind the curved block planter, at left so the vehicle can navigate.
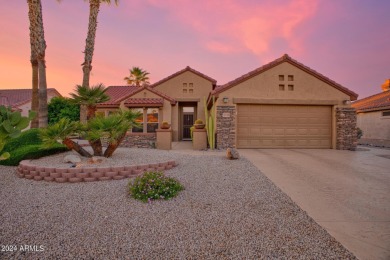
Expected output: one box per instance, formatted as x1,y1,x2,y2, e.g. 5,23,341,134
0,144,69,166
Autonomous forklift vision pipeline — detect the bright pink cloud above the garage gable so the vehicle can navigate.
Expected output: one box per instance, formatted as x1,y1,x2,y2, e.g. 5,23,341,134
148,0,318,58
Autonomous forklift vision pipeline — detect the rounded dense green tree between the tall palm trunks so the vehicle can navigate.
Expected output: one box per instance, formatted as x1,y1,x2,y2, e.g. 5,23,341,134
48,97,80,125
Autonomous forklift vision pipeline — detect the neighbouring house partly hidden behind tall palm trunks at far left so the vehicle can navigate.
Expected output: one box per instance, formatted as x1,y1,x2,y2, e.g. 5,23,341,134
0,88,62,116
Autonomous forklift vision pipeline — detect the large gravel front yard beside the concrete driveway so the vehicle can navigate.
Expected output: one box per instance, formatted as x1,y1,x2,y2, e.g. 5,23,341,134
0,149,355,259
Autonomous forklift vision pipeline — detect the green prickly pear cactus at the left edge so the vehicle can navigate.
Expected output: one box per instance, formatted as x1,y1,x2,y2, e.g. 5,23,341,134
0,106,36,161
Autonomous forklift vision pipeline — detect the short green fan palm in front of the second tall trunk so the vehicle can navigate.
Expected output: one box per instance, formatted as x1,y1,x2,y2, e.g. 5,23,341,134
70,84,110,120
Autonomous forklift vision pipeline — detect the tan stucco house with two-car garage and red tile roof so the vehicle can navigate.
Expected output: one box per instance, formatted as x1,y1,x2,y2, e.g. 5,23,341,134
97,54,358,149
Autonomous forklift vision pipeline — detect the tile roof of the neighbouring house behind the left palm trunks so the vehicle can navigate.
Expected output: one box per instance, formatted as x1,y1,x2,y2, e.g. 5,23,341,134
0,88,62,108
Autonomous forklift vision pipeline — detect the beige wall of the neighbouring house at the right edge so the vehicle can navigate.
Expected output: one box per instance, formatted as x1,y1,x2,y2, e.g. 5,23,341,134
357,111,390,141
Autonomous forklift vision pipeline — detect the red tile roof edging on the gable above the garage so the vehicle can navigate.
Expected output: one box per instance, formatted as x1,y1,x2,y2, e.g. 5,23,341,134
212,54,358,100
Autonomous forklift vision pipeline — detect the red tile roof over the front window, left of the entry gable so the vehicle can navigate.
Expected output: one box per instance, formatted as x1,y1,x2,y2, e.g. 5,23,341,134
98,86,176,107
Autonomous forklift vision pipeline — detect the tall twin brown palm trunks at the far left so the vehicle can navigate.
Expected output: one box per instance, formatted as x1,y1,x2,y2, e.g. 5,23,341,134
27,0,47,127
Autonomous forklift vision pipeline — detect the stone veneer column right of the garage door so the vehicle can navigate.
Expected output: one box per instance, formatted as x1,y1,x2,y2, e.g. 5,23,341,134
336,108,357,151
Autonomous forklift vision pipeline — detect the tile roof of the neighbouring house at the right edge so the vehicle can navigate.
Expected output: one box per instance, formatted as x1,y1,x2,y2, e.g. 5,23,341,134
352,91,390,112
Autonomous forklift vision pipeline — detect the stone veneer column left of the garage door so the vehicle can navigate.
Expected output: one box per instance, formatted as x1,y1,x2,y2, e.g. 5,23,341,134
216,106,236,149
